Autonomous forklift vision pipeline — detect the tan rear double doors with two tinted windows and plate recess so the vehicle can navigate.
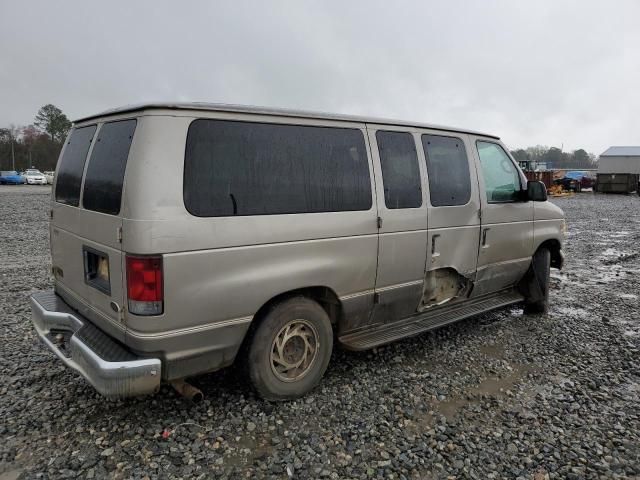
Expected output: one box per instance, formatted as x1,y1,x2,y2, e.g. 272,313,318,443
50,119,136,341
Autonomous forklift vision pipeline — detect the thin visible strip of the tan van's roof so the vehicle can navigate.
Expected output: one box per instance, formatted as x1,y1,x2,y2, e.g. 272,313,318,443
74,102,500,139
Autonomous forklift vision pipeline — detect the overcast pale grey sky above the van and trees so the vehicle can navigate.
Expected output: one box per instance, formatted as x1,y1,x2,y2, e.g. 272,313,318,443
0,0,640,154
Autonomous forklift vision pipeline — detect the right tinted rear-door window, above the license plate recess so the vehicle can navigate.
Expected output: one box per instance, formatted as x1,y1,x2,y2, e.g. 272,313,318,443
82,120,137,215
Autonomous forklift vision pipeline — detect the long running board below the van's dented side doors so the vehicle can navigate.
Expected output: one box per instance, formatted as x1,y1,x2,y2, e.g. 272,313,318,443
339,290,524,350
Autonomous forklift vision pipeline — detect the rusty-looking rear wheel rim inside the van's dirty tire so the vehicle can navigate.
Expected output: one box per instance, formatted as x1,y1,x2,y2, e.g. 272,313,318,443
270,319,320,382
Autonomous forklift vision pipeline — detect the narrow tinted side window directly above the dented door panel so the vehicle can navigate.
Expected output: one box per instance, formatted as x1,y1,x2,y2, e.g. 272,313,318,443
422,135,471,207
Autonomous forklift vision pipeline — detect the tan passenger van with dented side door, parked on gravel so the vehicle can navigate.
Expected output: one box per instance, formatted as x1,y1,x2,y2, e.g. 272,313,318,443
31,103,565,399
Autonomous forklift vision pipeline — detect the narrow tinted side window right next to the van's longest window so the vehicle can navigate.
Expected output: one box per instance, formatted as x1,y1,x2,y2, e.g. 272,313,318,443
376,131,422,208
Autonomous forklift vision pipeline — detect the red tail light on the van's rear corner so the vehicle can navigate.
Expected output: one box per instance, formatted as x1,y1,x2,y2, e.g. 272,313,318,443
127,255,164,315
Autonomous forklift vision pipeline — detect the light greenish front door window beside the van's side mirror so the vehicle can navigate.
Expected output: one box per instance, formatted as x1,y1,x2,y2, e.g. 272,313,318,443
476,141,522,203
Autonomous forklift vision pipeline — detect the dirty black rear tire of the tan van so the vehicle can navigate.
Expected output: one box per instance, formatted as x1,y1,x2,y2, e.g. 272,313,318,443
248,297,333,400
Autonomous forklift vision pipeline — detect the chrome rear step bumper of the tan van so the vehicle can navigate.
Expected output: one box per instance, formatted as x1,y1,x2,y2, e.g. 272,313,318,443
31,290,162,398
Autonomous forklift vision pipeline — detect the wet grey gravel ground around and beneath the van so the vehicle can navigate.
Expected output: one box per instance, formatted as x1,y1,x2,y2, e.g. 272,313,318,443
0,187,640,480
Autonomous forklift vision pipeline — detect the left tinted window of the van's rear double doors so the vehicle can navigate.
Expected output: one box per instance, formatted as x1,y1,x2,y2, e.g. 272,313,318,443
56,125,96,207
